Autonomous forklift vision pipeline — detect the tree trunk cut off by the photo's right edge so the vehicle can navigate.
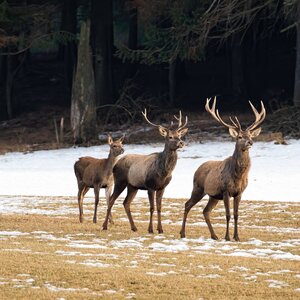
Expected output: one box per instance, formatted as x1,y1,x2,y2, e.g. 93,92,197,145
293,1,300,107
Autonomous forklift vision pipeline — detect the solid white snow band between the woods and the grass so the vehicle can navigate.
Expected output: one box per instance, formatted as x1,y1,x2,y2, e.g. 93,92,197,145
0,140,300,202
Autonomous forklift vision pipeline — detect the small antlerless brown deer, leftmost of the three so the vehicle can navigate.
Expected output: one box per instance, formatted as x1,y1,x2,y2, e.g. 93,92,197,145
74,135,124,223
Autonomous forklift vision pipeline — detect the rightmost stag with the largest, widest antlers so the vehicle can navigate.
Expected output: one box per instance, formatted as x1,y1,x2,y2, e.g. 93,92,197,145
180,97,266,241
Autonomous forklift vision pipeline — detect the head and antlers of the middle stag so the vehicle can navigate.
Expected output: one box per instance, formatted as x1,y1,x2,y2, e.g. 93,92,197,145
142,109,188,151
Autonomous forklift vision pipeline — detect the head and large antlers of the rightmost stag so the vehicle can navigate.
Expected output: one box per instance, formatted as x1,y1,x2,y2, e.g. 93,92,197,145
205,97,266,151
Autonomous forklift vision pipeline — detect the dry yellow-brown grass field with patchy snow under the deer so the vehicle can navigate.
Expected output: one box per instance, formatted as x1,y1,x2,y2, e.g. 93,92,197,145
0,196,300,299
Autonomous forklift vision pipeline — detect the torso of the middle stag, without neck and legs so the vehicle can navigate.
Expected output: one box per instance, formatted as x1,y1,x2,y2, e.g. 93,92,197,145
113,153,176,191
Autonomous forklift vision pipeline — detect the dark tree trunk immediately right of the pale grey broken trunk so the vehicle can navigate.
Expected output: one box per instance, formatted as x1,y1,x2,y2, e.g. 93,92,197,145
91,0,113,106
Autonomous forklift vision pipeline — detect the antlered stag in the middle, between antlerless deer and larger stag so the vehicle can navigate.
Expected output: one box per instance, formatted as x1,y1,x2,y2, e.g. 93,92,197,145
102,109,188,233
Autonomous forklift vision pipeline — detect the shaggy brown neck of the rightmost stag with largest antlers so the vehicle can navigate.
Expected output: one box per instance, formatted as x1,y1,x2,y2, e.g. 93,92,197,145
231,147,251,178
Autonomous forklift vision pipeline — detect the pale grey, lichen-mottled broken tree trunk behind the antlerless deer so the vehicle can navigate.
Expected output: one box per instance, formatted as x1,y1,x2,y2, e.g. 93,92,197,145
71,20,97,144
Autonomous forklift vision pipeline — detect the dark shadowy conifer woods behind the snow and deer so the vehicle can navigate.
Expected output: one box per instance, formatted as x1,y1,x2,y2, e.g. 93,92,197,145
0,0,300,143
